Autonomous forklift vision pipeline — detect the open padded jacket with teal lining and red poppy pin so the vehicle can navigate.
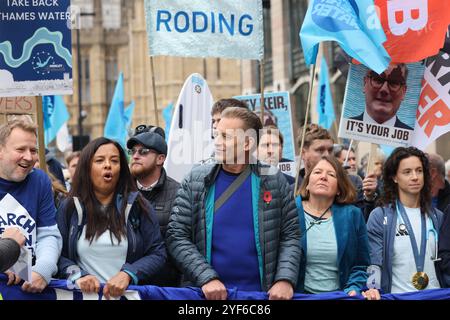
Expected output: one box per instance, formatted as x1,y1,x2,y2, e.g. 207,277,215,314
166,164,301,291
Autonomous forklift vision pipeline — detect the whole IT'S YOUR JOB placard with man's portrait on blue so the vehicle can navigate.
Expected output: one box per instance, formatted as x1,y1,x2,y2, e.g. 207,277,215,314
338,62,425,147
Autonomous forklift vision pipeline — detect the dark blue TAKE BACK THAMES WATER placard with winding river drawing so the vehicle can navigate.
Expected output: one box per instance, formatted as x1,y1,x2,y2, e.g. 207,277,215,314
0,0,72,97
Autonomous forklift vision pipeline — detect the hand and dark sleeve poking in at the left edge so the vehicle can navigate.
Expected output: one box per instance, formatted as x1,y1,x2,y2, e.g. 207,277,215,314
0,227,25,272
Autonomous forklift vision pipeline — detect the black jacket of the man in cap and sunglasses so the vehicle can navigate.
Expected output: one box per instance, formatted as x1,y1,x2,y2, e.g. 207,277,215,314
140,168,181,287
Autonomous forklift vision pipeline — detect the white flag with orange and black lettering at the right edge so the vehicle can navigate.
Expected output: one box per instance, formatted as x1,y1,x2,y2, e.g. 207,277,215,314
412,53,450,150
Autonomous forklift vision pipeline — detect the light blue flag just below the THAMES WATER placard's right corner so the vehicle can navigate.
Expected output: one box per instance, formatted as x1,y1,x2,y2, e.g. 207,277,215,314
42,96,70,146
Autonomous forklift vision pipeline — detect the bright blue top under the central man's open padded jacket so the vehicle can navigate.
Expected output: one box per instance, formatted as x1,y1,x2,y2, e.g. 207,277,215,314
211,170,261,291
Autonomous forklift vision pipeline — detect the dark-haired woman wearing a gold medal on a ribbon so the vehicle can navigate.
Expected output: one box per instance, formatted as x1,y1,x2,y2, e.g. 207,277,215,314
363,147,442,300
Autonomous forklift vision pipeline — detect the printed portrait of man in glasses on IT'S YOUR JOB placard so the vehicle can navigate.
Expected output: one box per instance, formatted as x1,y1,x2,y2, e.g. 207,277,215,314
351,63,413,130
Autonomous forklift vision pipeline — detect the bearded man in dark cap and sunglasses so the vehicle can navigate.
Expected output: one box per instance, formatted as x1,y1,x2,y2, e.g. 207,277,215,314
127,125,181,287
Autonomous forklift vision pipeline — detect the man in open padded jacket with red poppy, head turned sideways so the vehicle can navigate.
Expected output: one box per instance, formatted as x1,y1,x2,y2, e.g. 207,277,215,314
166,107,301,300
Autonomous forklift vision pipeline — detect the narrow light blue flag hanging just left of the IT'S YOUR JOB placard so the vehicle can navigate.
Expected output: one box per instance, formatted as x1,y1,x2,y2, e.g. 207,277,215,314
317,57,336,130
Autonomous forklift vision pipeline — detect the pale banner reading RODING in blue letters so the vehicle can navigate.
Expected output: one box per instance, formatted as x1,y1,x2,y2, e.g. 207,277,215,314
145,0,264,60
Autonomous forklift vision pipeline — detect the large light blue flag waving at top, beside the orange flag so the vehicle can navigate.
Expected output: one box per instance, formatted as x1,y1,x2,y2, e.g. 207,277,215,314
300,0,391,73
